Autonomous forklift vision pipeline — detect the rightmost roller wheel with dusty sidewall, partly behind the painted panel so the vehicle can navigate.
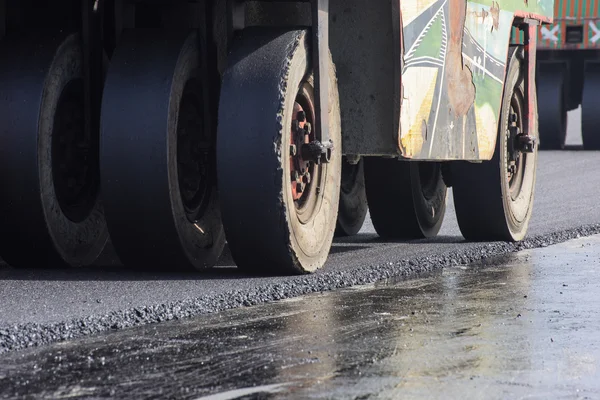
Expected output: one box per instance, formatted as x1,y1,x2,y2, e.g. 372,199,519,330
452,49,537,241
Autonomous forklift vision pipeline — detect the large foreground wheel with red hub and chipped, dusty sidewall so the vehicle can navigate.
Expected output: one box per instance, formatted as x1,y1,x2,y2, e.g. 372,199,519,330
217,30,342,274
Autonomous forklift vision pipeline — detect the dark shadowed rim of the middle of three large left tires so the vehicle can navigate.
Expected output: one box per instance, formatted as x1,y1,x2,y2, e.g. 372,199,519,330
177,79,214,223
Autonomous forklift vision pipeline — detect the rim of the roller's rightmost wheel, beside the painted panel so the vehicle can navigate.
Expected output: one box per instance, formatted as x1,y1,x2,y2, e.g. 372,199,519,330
505,86,527,201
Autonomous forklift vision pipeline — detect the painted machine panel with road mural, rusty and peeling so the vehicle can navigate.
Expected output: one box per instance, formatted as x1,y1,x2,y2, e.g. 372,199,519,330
398,0,554,160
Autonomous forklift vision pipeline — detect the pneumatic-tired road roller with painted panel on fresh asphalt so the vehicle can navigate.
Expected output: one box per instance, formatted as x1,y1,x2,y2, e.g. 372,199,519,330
0,0,553,274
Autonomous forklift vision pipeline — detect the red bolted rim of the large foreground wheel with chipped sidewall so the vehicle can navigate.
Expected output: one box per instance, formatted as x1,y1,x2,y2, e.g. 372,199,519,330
289,83,323,223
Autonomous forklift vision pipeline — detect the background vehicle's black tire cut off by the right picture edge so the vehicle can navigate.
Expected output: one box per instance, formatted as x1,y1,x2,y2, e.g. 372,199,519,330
581,62,600,150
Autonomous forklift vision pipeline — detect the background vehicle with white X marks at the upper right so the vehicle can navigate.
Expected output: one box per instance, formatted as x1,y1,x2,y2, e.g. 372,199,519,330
537,0,600,150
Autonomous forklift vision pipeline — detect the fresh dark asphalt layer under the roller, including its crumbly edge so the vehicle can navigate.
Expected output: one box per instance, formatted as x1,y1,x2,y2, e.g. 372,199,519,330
0,108,600,353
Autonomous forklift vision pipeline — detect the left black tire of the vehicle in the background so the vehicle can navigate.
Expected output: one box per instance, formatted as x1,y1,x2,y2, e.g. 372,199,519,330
536,64,567,150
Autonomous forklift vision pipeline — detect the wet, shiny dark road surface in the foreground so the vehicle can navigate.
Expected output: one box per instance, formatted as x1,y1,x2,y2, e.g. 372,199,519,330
0,235,600,400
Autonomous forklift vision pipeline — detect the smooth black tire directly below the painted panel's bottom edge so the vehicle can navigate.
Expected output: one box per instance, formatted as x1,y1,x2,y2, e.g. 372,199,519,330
365,157,448,240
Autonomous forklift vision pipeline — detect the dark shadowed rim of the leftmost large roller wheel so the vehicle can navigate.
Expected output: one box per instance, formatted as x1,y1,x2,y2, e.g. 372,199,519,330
52,79,100,222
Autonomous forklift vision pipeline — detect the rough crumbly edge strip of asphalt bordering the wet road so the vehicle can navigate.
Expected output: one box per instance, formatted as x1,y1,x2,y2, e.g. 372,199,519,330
0,224,600,354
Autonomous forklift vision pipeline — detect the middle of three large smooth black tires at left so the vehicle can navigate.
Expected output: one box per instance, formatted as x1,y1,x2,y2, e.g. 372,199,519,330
100,30,225,271
